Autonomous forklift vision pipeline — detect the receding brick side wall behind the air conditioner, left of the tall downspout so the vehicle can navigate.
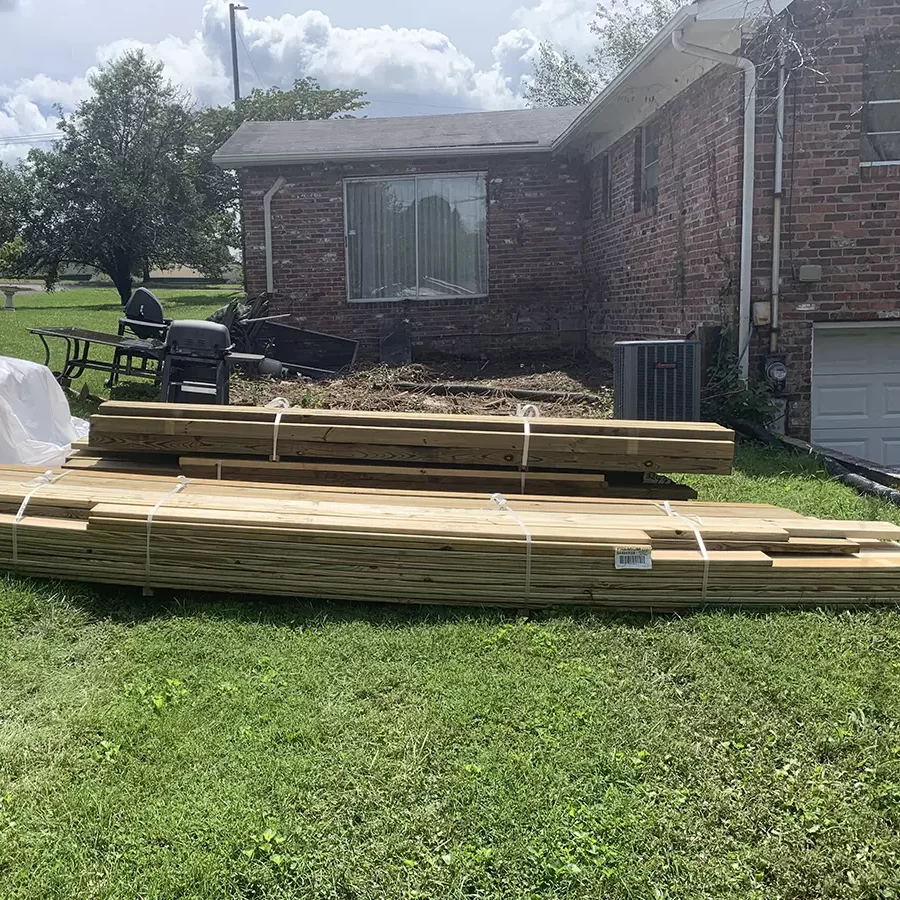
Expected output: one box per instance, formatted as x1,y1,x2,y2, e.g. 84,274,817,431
585,60,742,353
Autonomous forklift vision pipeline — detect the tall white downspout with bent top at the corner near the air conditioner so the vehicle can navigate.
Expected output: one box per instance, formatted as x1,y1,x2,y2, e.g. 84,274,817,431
672,29,756,379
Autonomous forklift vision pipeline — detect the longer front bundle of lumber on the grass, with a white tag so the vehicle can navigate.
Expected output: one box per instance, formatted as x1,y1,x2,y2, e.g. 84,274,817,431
0,467,900,609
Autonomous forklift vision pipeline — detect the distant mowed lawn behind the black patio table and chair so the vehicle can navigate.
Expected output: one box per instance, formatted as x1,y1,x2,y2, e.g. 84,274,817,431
0,285,236,397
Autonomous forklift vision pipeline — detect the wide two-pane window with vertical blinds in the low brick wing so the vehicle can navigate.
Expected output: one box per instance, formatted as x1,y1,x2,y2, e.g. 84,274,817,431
345,175,487,300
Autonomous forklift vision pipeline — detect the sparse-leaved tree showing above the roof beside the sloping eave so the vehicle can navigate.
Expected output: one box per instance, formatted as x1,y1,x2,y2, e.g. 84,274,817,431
525,0,680,106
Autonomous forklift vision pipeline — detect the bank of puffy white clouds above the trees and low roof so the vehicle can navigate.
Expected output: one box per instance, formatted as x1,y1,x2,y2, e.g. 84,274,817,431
0,0,595,160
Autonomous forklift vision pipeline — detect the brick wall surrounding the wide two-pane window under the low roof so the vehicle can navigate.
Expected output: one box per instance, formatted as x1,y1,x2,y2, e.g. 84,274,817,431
242,155,584,356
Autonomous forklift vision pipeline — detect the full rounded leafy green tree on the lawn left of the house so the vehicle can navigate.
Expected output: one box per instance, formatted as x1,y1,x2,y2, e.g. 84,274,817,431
22,51,236,303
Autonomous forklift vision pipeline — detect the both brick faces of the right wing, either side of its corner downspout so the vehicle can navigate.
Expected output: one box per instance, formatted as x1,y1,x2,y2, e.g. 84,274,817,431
585,0,900,434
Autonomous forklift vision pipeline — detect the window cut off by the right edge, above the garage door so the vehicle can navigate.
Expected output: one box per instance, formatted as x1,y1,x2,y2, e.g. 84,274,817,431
860,41,900,165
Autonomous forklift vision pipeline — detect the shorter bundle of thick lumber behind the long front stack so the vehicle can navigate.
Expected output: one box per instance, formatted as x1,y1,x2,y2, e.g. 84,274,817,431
73,402,734,496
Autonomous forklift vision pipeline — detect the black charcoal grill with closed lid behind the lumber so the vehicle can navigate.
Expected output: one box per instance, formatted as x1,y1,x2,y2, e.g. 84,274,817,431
160,319,232,405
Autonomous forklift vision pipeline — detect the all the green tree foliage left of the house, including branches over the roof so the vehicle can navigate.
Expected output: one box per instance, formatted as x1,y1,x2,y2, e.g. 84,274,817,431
14,59,366,303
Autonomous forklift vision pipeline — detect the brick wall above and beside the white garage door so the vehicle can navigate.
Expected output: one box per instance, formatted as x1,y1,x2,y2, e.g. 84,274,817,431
751,0,900,435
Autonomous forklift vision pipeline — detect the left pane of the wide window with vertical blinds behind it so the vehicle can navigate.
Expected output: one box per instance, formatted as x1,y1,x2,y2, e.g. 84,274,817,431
347,178,416,300
